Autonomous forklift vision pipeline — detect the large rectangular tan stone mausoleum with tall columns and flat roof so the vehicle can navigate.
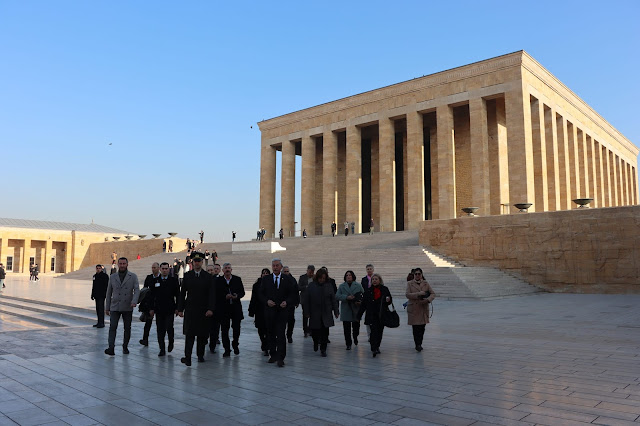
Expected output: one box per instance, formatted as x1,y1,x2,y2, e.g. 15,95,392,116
258,51,639,235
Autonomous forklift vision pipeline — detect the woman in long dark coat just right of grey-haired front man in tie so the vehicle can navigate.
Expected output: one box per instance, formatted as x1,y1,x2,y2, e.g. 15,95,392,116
303,268,339,356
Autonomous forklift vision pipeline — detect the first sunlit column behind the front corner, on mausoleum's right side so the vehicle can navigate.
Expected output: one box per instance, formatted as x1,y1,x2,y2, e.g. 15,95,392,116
531,99,549,212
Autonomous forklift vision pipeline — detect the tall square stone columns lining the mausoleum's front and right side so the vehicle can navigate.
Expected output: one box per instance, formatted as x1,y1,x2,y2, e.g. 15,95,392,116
260,87,638,235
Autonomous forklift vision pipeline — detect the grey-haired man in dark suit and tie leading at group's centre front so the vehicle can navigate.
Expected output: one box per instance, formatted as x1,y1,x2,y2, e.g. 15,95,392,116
260,259,298,367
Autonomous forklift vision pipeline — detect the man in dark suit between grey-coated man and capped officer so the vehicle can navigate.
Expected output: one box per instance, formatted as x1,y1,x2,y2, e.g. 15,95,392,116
149,262,180,356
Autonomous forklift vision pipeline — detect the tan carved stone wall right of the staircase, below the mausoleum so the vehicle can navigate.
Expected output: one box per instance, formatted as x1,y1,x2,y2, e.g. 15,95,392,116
420,206,640,293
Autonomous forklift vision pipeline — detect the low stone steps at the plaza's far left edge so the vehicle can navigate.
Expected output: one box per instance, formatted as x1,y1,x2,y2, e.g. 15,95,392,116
0,295,100,329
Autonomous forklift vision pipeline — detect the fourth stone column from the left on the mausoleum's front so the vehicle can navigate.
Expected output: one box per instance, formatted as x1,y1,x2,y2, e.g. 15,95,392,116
322,130,340,235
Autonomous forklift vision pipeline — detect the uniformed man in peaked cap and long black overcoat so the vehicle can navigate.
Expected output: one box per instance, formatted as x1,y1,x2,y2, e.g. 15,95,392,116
178,251,216,366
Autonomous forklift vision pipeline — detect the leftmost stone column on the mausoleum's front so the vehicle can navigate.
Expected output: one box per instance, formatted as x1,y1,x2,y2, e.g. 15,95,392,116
258,140,276,238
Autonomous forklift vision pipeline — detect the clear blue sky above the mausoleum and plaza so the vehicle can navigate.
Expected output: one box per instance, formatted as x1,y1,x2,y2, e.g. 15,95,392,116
0,0,640,241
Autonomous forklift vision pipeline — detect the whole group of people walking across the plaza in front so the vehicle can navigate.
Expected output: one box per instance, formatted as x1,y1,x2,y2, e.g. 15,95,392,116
91,251,436,367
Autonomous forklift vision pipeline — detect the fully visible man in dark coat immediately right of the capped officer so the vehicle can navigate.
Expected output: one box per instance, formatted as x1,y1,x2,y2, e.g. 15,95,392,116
211,263,244,358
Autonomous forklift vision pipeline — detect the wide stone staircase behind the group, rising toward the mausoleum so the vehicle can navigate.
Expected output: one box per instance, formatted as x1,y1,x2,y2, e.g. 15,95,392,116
63,231,540,300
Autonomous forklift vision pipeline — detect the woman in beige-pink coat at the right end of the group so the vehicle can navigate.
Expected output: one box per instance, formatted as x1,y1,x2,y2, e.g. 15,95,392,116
406,268,436,352
